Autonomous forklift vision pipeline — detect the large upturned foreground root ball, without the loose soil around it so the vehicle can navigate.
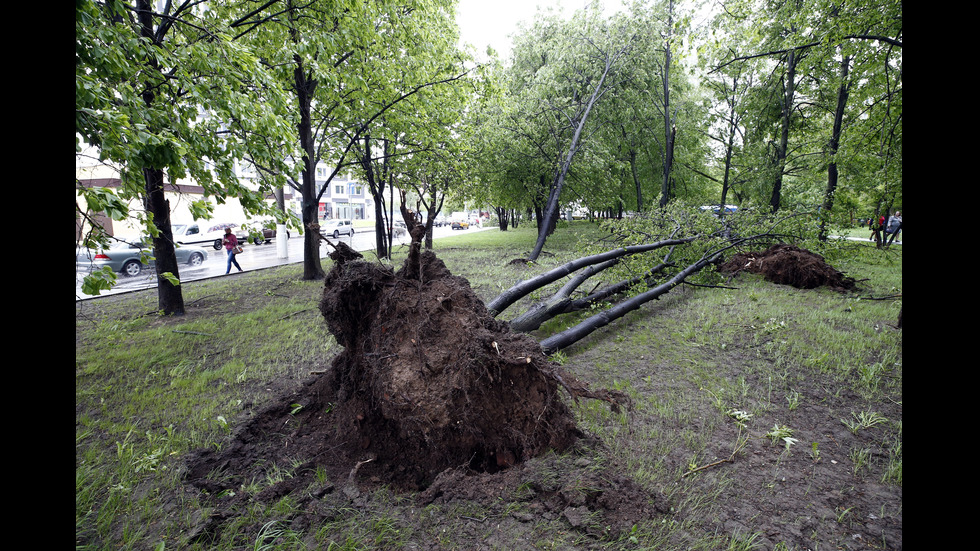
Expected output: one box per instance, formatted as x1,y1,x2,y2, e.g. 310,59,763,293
319,246,596,486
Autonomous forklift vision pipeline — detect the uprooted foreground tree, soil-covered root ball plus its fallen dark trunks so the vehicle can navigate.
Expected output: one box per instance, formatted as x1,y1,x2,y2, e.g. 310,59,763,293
189,201,856,504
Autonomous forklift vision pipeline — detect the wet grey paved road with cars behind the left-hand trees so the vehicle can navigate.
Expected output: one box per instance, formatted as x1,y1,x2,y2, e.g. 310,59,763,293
75,226,491,301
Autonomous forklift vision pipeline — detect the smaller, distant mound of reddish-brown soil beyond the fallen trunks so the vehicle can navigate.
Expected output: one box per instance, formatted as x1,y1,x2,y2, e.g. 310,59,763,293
718,243,855,290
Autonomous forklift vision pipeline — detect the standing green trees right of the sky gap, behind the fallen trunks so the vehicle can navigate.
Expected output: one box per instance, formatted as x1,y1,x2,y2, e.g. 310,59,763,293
462,0,902,260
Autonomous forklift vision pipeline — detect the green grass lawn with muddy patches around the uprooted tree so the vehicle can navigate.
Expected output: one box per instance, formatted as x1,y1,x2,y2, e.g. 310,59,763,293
75,223,902,549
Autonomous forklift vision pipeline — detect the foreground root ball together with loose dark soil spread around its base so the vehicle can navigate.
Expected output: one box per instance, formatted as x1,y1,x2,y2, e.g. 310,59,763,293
186,244,658,542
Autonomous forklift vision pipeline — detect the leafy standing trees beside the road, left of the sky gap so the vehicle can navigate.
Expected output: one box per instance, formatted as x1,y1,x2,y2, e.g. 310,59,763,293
75,0,468,314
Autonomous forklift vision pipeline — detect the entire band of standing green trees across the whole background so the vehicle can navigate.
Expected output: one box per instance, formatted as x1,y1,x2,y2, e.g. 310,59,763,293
76,0,902,314
